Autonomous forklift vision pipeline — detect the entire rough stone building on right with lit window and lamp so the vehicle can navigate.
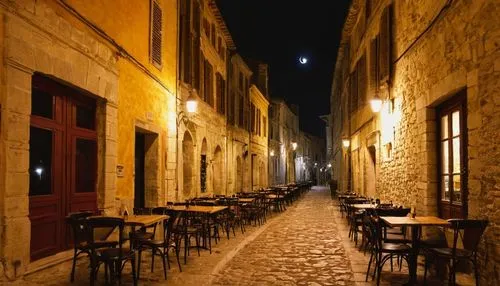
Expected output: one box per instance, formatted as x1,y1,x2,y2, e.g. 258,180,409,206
331,0,500,285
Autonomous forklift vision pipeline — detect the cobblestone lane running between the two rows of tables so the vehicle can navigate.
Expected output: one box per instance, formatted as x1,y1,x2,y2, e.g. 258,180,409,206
214,187,353,285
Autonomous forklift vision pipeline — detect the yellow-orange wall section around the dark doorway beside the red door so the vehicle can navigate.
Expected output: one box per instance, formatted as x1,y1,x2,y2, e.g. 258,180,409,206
63,0,177,204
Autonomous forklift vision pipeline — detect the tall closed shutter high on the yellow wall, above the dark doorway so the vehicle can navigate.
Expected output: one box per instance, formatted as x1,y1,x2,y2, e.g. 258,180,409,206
150,0,163,68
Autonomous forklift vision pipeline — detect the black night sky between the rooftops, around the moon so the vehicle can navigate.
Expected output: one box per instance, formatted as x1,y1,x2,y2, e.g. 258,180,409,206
217,0,350,136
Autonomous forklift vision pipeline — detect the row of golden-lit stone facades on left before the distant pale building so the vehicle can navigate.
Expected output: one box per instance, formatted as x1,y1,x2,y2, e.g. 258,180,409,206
0,0,268,283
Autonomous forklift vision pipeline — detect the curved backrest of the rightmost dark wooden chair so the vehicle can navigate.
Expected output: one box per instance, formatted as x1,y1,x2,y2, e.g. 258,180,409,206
448,219,488,252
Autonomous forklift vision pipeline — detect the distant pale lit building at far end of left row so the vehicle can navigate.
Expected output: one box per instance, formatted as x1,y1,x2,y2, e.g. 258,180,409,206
269,98,299,185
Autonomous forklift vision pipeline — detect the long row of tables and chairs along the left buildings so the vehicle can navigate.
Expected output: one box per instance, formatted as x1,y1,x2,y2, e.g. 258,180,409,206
66,183,311,285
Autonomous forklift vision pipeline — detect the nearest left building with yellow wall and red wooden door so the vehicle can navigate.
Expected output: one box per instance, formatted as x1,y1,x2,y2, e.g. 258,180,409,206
0,0,177,280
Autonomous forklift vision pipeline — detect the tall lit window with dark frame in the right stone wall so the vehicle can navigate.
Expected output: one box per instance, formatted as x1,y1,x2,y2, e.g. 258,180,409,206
436,91,467,219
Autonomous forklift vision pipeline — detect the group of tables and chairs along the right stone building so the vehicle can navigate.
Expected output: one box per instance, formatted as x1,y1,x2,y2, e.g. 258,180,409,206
337,193,488,285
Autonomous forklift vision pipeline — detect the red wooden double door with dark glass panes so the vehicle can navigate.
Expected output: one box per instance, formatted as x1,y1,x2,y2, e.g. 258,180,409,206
29,75,97,260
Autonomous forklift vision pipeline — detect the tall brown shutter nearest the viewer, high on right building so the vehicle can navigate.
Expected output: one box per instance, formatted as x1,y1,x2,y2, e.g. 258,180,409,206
379,5,392,84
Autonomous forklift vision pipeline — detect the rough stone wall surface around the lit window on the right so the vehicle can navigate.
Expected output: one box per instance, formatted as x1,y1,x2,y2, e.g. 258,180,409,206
332,0,500,284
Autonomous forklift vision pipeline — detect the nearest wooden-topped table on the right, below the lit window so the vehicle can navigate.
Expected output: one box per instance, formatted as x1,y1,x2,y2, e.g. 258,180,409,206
380,216,450,285
